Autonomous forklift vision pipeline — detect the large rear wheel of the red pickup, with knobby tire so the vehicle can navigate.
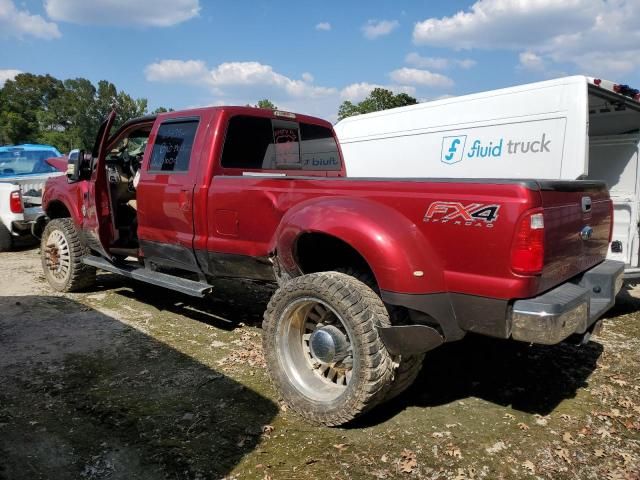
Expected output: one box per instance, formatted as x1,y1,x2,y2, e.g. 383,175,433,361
263,272,393,426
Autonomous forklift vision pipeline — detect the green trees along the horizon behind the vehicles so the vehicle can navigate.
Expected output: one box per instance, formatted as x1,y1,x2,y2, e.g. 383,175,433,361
0,73,417,152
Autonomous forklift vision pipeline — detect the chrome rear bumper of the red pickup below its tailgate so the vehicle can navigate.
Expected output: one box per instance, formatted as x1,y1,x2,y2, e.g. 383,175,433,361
511,260,624,345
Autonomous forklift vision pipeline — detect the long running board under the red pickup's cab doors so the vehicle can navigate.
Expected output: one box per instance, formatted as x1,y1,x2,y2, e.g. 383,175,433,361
82,256,213,298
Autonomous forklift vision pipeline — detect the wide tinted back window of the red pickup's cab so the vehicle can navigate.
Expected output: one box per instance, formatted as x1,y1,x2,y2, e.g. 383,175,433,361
221,115,342,174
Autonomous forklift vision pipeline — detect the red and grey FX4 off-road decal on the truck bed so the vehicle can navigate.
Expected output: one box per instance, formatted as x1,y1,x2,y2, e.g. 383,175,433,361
423,202,500,228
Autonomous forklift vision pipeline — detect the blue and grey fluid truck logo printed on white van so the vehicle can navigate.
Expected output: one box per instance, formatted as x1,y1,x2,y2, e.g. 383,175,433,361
440,133,551,165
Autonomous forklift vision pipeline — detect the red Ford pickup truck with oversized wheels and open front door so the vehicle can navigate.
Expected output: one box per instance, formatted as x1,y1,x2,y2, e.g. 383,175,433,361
41,107,623,425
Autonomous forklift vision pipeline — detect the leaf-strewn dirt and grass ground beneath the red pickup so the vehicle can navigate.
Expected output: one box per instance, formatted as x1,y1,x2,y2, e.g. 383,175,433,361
0,249,640,480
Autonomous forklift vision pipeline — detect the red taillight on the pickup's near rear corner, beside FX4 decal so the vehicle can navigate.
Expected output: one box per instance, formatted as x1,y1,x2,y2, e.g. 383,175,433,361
511,209,544,275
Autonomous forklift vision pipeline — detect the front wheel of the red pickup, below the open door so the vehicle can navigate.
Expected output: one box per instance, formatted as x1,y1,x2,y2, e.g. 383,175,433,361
40,218,96,292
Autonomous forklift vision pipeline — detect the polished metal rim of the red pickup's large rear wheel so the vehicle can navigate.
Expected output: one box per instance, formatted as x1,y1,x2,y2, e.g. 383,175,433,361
276,297,357,402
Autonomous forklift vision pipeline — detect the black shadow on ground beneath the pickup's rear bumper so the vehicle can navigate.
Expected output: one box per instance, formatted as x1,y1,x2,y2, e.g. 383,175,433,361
361,335,603,425
